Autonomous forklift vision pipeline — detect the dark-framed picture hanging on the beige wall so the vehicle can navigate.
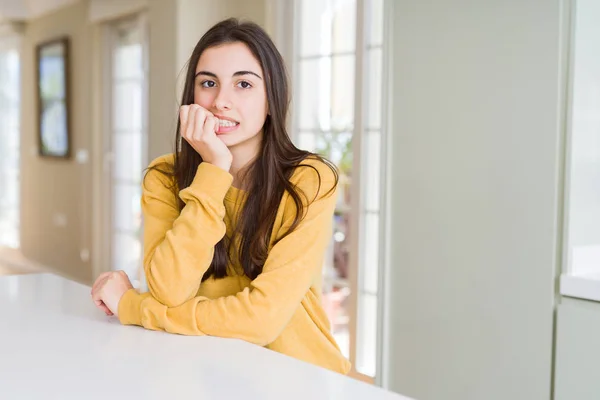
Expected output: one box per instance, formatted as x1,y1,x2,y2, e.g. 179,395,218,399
36,37,71,158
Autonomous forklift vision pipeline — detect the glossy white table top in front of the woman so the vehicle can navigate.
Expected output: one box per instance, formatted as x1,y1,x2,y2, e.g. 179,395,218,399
0,274,407,400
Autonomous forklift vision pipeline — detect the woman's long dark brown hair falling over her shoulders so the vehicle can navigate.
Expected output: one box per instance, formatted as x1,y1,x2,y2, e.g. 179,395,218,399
150,18,338,281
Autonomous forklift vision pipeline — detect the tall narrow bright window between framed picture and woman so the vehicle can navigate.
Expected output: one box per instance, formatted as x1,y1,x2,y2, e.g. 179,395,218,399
106,17,148,287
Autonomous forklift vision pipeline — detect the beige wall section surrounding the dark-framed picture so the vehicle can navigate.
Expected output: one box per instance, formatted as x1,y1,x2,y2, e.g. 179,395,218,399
21,1,92,281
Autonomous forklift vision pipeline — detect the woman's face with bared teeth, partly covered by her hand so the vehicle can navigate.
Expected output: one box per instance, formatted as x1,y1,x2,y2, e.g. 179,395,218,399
194,42,268,151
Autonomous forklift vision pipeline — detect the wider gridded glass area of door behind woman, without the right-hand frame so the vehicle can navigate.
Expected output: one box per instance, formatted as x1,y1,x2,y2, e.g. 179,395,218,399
294,0,356,366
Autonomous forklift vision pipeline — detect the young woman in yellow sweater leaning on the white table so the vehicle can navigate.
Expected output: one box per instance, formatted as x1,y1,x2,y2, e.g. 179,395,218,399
92,19,350,373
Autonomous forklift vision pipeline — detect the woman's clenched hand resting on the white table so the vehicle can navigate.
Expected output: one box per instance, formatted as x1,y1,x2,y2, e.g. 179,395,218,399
92,271,133,317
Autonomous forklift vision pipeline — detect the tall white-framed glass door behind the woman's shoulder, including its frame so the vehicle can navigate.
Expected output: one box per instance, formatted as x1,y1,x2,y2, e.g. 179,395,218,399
292,0,385,381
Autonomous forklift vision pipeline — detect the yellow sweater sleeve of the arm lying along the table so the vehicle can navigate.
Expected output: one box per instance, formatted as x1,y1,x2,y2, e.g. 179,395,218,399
119,161,336,346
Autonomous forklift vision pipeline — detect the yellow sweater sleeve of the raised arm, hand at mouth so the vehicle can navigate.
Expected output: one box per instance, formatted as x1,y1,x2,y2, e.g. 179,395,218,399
142,156,233,307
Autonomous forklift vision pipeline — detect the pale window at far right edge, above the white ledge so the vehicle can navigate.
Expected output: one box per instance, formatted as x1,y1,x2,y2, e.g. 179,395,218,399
565,0,600,279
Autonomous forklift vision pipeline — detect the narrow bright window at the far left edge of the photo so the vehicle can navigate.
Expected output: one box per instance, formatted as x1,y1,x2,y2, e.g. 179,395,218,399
0,39,21,249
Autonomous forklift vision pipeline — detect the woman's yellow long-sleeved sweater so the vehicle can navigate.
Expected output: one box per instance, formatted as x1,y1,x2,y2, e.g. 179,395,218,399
118,155,350,374
